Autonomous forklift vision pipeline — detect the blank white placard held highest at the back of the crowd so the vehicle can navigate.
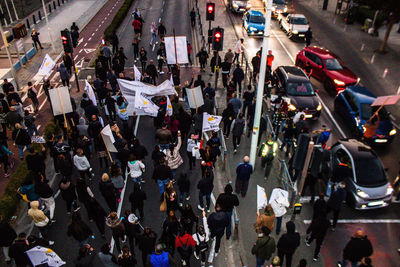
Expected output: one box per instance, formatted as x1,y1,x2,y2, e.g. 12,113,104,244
164,36,189,64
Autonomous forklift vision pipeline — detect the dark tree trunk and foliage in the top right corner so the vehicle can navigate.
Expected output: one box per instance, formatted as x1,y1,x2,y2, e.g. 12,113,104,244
366,0,400,53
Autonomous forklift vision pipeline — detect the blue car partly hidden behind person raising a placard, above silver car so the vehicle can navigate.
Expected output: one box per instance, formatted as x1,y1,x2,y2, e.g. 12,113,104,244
334,86,396,144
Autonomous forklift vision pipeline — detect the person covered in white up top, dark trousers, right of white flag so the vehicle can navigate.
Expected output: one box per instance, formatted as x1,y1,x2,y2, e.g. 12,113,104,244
269,188,289,235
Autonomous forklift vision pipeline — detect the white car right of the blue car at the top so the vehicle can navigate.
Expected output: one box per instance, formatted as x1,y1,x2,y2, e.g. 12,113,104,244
279,14,309,39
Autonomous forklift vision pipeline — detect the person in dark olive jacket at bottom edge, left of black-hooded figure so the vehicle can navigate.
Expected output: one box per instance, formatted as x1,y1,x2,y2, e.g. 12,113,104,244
251,227,275,267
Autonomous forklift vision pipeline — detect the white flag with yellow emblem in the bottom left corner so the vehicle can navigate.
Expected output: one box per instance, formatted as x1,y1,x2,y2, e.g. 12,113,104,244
25,246,65,267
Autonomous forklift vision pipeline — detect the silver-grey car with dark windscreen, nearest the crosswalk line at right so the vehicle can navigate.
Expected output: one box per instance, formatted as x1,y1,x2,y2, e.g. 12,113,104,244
328,139,393,210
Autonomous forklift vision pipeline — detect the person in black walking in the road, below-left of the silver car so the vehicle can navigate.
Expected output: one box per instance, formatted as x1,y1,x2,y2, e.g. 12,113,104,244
306,215,330,261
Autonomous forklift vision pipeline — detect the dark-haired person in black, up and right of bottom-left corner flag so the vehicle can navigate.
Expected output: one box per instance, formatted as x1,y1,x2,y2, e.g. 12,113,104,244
67,212,94,247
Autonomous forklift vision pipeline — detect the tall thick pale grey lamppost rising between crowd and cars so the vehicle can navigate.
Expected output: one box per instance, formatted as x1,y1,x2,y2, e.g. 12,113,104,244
250,0,272,167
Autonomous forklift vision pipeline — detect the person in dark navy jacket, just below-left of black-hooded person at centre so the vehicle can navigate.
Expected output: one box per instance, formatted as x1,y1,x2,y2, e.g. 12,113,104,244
207,204,230,257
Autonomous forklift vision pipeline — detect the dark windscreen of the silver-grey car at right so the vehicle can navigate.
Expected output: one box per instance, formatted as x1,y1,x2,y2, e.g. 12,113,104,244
354,156,387,187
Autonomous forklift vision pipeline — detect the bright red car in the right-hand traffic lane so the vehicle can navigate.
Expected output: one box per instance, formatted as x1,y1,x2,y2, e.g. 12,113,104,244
296,46,359,92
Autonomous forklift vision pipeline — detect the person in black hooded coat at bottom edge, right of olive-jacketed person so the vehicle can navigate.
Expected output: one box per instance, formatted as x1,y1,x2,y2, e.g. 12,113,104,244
277,221,300,267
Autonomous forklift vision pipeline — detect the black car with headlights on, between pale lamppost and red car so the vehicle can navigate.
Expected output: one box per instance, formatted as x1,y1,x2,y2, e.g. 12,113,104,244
272,66,322,119
